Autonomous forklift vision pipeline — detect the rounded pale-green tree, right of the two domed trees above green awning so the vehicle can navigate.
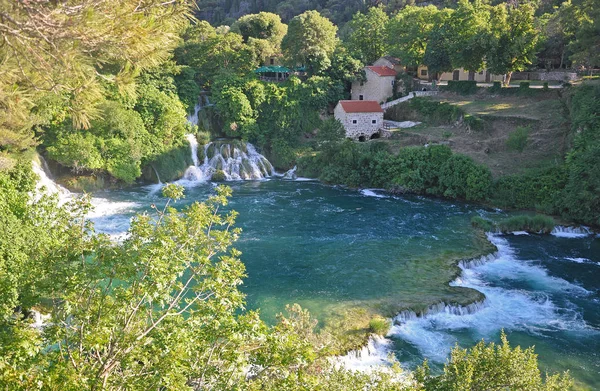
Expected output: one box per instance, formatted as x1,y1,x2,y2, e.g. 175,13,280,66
281,11,337,74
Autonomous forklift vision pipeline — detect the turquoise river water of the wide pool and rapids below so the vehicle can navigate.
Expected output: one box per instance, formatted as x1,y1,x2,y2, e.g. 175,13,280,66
85,179,600,390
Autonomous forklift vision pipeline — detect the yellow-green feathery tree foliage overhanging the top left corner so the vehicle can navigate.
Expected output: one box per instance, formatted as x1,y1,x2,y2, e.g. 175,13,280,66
0,0,188,148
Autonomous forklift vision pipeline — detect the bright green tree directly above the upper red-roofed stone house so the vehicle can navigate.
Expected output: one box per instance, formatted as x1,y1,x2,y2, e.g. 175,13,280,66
347,6,389,64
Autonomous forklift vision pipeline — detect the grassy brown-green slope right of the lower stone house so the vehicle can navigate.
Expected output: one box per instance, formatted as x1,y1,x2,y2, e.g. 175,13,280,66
386,91,568,177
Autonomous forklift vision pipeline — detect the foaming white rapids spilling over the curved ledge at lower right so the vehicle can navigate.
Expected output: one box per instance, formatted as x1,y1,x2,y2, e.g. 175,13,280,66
390,235,591,362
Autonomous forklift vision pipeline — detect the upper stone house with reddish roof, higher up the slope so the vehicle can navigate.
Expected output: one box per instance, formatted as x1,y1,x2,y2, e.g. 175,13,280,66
351,65,397,103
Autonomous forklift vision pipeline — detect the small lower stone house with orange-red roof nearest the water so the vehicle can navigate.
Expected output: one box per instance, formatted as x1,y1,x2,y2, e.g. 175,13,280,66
333,100,383,141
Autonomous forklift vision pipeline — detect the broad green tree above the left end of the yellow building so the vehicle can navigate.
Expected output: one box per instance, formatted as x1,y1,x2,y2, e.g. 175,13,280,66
387,5,444,66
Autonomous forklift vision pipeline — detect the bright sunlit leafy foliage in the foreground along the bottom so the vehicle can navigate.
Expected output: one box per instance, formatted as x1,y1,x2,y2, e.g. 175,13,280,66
0,167,570,391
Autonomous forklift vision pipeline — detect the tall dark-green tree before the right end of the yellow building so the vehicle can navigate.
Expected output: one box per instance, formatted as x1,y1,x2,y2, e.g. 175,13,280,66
486,3,538,84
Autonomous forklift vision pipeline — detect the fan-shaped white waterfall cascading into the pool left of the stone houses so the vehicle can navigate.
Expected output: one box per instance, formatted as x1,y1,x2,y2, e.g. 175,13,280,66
183,134,275,182
